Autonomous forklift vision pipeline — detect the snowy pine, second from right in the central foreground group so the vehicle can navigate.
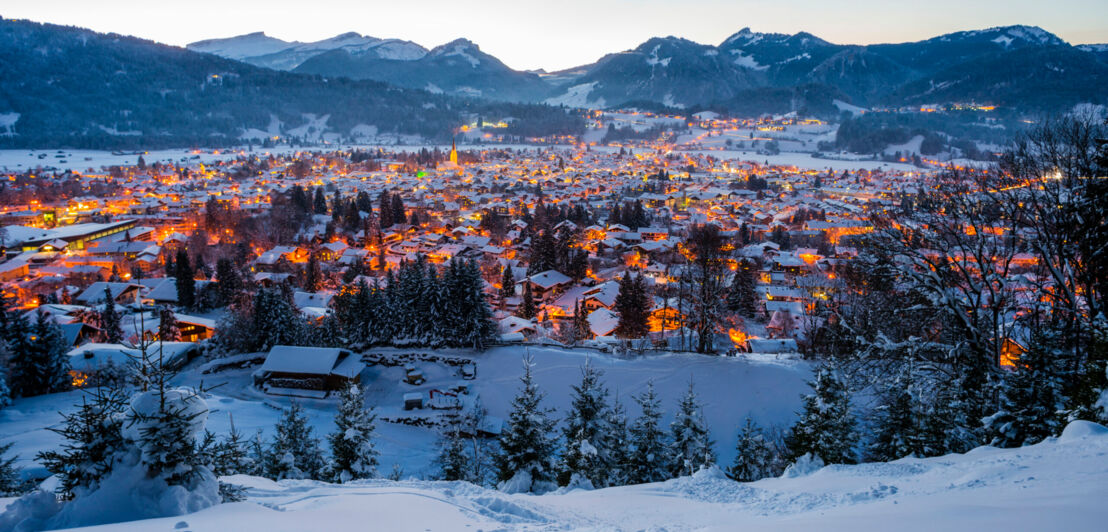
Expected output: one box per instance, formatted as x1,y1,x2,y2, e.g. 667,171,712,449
627,380,673,484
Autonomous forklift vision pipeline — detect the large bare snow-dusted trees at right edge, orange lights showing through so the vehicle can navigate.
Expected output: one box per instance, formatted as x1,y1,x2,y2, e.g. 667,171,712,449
809,116,1108,458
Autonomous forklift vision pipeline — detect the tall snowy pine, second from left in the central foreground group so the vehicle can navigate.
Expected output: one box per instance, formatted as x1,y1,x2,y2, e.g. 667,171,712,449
557,359,612,488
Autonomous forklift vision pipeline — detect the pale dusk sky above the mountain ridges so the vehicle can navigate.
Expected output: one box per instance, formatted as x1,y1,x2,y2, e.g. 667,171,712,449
0,0,1108,70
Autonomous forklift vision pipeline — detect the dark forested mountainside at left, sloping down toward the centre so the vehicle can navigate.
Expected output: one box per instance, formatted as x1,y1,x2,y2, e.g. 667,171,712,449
0,20,584,149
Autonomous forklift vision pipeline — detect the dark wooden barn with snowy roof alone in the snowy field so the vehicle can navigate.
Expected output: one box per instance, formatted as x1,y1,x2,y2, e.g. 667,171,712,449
254,346,366,398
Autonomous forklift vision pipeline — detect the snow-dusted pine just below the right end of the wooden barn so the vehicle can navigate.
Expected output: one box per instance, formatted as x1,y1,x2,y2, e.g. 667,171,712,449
327,385,378,482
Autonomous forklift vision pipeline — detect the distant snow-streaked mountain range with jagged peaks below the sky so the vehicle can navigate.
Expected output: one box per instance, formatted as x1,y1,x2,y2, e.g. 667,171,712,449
187,25,1108,110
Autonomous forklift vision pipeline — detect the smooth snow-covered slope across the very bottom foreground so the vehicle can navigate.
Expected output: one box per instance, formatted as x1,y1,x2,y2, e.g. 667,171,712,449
28,422,1108,532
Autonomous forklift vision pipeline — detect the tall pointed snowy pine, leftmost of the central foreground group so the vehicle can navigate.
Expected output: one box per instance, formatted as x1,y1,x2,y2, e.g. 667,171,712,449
495,356,557,493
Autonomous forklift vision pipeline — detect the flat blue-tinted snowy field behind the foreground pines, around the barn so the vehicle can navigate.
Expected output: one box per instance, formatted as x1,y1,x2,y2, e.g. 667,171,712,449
0,347,810,478
